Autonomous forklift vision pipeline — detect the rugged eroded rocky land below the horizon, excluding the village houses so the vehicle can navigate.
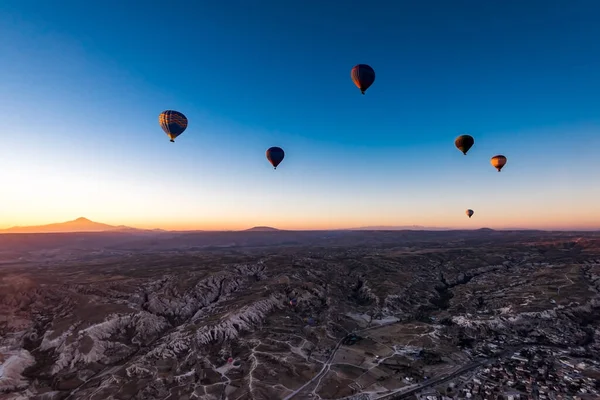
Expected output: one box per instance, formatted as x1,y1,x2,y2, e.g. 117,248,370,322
0,230,600,400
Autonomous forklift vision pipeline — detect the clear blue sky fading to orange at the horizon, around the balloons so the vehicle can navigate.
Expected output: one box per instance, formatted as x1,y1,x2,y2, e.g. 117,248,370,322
0,0,600,229
